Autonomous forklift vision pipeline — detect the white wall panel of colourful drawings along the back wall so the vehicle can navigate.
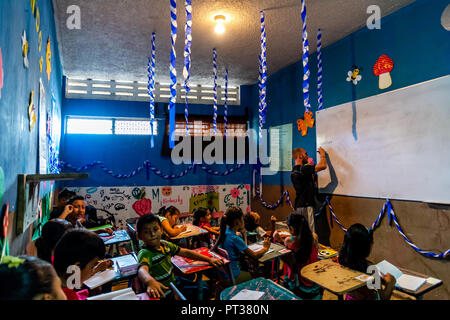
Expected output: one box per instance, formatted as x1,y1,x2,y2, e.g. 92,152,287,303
69,184,250,227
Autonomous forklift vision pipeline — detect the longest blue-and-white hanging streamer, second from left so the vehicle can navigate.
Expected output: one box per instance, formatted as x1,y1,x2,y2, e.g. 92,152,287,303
169,0,177,149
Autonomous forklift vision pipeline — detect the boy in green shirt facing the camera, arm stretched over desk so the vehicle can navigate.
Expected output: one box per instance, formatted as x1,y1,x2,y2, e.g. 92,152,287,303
136,214,223,298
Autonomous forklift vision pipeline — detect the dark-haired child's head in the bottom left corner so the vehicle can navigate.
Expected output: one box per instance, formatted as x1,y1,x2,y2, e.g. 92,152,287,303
0,256,66,301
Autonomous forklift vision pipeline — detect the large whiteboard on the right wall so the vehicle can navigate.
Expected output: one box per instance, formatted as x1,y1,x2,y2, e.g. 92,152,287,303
316,76,450,203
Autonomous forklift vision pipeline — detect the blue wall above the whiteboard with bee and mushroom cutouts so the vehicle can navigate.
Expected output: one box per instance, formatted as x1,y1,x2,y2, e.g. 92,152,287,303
241,0,450,185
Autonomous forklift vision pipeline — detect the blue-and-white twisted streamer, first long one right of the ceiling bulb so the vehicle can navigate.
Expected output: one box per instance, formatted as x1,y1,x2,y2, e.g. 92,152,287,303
259,10,267,138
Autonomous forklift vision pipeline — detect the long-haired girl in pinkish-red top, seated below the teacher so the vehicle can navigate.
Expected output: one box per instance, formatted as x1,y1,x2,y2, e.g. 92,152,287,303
275,213,322,300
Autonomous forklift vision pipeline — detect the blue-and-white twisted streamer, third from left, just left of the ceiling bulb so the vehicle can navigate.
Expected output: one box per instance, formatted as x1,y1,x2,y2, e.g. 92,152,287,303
183,0,192,136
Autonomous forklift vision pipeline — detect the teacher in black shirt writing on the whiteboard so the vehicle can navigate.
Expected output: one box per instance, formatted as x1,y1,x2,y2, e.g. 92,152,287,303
291,147,327,240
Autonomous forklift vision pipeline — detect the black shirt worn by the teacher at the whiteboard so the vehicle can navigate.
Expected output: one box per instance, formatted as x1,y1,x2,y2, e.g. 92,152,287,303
291,164,316,209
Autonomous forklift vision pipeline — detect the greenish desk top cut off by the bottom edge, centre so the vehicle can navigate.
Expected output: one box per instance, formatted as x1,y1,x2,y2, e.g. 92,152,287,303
220,278,301,300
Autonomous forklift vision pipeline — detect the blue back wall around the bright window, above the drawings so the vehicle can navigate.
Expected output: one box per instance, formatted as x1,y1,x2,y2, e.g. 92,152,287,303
61,93,251,187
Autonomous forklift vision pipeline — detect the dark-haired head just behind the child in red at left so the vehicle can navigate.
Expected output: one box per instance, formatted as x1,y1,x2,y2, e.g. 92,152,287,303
35,219,73,263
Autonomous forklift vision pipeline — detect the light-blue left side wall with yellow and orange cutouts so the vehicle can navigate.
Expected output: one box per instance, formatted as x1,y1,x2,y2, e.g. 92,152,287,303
0,0,62,211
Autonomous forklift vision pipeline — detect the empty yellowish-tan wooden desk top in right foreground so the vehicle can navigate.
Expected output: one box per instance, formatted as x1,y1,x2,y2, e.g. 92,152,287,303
301,259,366,300
